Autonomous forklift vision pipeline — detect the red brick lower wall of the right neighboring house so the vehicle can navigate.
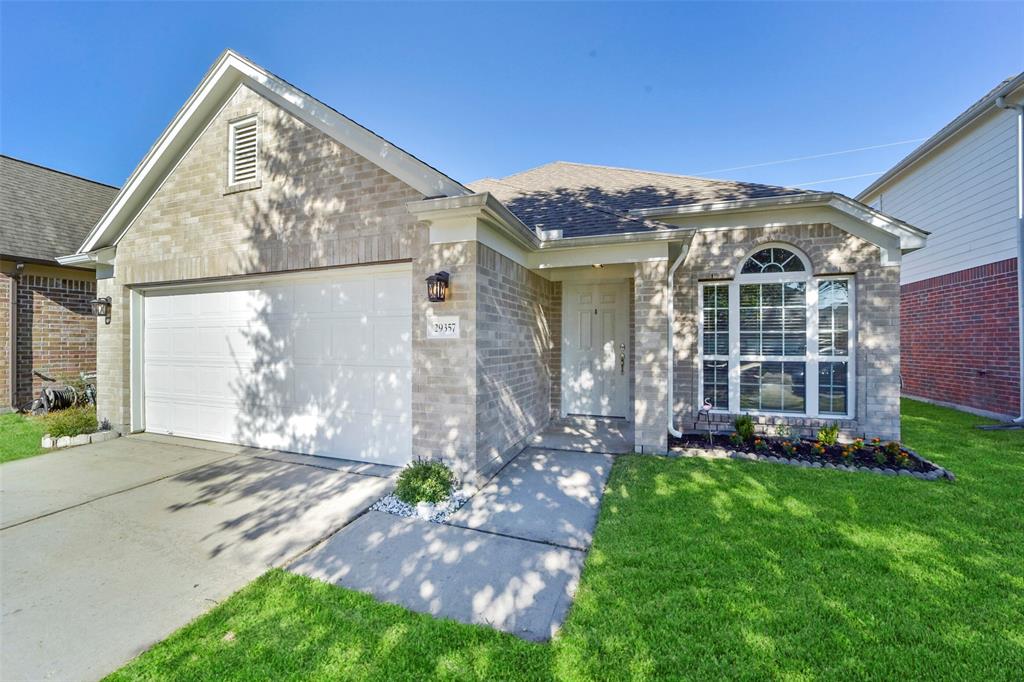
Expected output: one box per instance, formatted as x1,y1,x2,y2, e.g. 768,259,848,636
900,258,1020,416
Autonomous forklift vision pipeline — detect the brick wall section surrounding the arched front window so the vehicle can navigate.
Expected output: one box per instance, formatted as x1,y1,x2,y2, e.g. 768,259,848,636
675,224,900,439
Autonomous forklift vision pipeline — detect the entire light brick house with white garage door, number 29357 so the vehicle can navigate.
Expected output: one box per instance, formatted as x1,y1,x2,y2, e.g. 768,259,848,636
61,51,925,480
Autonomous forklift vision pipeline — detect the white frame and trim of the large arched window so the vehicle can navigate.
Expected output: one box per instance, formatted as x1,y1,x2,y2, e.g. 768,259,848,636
696,243,857,420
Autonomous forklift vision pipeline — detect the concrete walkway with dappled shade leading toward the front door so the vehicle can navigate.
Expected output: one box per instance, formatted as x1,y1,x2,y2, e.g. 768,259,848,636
289,450,612,641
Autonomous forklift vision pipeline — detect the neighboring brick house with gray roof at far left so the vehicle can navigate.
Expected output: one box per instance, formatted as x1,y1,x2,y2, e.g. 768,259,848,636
0,156,118,410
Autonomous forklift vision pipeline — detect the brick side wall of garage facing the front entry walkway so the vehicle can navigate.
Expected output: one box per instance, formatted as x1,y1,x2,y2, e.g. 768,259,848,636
476,245,561,471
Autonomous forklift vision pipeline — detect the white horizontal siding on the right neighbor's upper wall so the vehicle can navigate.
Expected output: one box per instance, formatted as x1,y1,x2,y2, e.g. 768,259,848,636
864,104,1017,284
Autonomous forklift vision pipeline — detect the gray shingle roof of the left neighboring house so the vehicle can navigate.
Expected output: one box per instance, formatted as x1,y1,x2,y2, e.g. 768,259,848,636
0,155,118,261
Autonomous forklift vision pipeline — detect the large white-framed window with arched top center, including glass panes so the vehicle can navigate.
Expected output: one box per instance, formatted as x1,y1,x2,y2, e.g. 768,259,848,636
699,244,853,417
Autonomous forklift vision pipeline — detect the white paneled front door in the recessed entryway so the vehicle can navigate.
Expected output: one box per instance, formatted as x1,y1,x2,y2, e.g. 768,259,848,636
562,281,632,417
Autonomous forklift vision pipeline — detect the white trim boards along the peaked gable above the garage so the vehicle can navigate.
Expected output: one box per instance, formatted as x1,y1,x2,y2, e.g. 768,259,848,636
78,50,470,254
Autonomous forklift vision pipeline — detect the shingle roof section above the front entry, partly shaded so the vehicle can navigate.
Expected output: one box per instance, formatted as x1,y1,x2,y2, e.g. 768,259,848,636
467,161,818,237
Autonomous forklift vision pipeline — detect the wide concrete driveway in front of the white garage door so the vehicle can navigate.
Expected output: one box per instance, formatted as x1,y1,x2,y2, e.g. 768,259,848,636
0,435,395,680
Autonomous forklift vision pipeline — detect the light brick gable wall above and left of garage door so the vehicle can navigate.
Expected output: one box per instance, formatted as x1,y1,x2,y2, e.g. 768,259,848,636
97,86,428,430
